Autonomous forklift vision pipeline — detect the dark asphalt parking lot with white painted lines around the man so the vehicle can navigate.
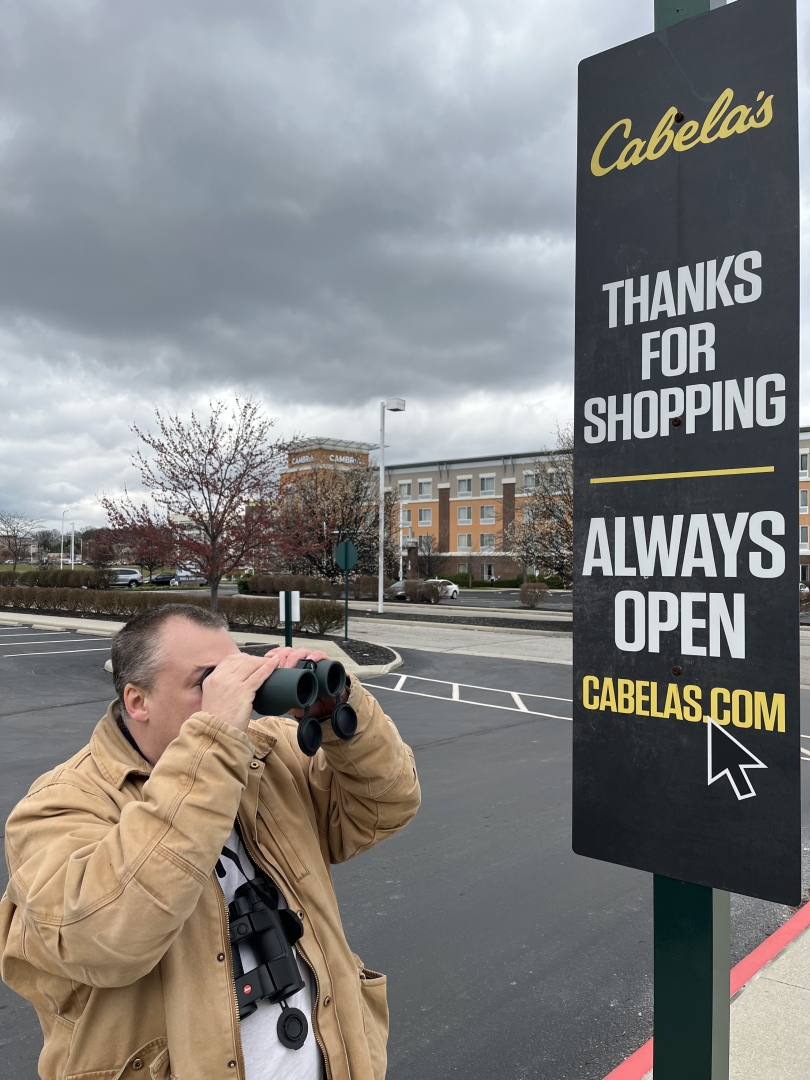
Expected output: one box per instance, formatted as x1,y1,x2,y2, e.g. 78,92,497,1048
0,627,810,1080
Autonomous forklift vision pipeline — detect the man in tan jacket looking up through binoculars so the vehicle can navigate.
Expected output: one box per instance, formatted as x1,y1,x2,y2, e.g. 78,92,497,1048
0,605,419,1080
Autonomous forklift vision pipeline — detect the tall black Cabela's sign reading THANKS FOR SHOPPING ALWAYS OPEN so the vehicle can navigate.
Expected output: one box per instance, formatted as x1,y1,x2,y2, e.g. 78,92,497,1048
573,0,800,904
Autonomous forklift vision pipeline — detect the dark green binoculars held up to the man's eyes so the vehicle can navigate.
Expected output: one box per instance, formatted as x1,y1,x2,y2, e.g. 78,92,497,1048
203,660,357,757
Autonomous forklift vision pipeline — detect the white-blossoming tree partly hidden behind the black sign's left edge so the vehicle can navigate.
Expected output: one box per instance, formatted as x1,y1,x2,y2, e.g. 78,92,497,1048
504,423,573,582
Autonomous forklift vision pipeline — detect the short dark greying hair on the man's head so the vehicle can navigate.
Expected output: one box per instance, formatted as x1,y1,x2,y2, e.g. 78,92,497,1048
111,604,228,720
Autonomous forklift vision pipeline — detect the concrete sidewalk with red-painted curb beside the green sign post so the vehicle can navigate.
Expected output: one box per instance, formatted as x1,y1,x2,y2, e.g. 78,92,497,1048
605,905,810,1080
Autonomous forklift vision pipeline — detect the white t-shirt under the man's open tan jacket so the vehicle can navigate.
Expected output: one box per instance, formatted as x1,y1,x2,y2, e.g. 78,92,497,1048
217,827,323,1080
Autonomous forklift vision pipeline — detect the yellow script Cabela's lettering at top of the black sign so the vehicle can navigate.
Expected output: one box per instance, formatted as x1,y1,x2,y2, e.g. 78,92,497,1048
591,90,773,176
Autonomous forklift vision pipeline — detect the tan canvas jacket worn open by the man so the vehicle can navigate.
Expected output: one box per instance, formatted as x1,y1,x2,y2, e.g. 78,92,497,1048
0,680,419,1080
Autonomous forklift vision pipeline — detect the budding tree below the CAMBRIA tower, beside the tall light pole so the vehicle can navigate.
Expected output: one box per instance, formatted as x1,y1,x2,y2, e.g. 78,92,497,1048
270,465,400,581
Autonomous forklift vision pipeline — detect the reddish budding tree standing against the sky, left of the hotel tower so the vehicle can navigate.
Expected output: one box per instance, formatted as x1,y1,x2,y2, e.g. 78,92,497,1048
102,399,285,611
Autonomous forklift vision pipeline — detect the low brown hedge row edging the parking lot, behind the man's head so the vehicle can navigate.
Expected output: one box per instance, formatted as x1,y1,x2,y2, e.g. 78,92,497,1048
0,585,343,634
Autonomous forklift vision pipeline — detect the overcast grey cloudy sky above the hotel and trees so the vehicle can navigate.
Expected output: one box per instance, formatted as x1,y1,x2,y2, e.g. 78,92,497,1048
0,0,810,527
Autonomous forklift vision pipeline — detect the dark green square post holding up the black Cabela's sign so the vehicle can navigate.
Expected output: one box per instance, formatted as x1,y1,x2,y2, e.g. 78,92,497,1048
652,8,731,1080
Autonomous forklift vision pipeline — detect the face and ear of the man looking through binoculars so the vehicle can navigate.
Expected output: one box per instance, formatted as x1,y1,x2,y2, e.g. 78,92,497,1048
124,616,239,765
